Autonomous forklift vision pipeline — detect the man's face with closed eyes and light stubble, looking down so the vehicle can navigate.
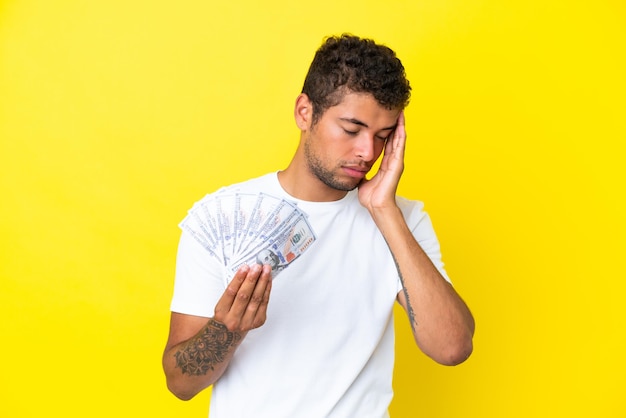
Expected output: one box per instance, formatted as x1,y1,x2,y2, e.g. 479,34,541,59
304,93,400,191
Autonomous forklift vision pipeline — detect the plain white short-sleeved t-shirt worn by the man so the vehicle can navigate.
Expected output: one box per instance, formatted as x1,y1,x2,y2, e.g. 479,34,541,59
171,173,448,418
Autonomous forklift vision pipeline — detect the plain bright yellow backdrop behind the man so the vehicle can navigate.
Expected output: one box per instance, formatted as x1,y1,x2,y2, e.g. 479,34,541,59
0,0,626,418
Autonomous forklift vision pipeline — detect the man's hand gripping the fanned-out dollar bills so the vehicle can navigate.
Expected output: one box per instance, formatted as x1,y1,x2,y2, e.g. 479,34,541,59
215,264,271,331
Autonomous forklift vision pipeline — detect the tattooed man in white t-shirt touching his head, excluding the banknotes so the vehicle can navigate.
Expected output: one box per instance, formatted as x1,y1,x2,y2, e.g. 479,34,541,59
163,35,474,418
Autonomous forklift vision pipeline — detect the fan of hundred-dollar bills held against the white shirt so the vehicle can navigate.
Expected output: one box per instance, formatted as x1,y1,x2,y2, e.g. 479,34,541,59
179,192,315,278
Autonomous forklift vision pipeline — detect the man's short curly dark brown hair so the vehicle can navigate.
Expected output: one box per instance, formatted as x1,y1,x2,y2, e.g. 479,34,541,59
302,34,411,124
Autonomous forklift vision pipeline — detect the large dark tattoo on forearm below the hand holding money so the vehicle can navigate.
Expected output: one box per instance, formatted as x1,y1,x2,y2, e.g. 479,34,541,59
174,318,241,376
